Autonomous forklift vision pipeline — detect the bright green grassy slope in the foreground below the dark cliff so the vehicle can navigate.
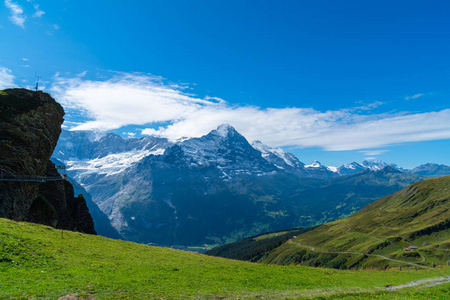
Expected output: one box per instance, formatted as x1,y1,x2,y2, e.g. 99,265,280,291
0,219,450,299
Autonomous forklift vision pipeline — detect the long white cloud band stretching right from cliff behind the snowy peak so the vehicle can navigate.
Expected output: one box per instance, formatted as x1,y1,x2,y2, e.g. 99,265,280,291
52,73,450,151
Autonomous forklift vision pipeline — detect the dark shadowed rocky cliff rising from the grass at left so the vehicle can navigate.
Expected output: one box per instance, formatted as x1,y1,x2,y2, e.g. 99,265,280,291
0,89,95,234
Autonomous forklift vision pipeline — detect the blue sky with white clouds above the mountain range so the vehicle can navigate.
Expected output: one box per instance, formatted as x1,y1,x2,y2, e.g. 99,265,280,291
0,0,450,168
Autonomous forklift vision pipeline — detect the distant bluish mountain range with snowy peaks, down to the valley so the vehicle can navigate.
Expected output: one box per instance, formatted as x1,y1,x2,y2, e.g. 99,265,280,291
53,125,450,245
